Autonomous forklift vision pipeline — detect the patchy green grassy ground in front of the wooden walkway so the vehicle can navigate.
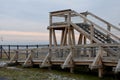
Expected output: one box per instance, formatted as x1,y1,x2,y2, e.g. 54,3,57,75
0,68,117,80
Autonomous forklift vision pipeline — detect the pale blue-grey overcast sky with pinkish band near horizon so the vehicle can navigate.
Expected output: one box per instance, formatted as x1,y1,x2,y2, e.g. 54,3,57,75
0,0,120,42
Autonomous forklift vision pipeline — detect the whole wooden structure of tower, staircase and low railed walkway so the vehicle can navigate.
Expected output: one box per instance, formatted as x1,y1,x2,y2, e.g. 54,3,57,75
6,9,120,77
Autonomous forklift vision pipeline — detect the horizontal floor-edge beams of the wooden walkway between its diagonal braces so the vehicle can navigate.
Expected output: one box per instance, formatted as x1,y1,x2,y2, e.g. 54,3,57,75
12,58,118,67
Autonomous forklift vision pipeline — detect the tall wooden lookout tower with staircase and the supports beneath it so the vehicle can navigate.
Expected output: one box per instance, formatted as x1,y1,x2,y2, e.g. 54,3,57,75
48,9,120,77
